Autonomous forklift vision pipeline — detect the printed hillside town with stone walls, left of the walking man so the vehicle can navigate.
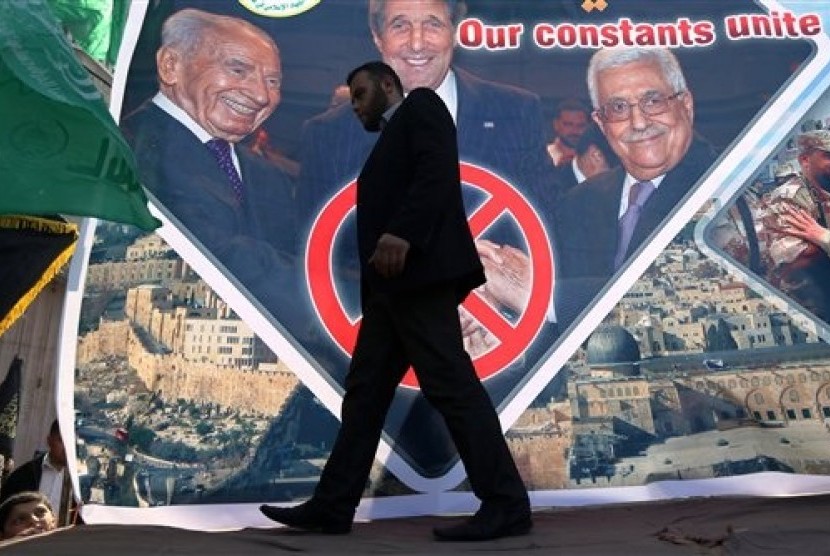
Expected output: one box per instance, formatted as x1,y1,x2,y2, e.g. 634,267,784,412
75,225,298,506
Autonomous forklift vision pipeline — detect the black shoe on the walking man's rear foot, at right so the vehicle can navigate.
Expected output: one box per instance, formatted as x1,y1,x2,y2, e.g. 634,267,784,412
432,505,533,541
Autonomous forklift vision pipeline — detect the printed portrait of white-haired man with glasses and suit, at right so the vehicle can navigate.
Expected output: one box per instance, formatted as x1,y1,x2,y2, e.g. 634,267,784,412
555,48,715,329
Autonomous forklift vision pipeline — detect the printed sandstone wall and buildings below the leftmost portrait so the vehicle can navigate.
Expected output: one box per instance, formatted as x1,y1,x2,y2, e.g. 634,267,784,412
78,235,298,415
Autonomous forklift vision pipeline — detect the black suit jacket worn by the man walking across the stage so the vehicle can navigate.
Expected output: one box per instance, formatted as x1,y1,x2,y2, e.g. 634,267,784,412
357,88,484,302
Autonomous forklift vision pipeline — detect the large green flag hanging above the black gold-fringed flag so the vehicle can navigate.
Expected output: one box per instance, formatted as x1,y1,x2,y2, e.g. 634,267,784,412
0,0,160,231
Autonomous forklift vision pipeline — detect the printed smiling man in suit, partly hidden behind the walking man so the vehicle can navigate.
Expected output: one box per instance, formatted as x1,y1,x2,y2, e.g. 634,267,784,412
298,0,553,228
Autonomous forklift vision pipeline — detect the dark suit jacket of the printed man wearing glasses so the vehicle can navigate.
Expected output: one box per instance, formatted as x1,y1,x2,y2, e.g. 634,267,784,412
555,139,715,330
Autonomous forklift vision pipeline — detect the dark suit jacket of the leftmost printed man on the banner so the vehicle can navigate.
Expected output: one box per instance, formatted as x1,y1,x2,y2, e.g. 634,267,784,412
121,101,307,327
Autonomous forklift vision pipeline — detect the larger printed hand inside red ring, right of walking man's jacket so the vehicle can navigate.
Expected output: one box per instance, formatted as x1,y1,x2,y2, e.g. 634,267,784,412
476,239,532,313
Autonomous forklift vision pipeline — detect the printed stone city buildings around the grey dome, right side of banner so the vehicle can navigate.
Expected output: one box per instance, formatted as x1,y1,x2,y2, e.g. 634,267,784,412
567,244,830,484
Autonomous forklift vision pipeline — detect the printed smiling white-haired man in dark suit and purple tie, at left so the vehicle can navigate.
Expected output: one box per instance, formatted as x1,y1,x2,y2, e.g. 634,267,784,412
121,9,306,330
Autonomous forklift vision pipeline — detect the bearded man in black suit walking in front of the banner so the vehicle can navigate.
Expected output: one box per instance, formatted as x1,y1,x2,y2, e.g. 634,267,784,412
262,62,531,540
